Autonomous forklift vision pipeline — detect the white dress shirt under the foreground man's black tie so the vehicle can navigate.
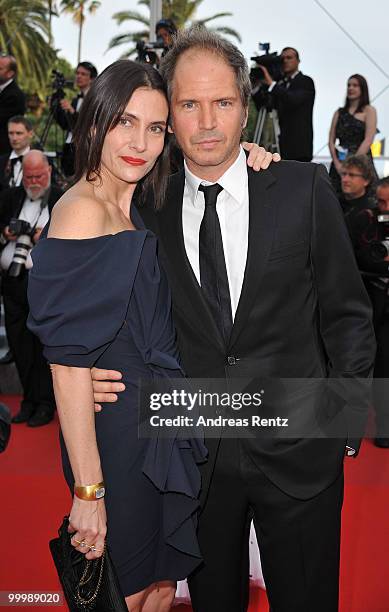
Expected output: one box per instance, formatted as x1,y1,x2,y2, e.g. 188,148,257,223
182,148,249,318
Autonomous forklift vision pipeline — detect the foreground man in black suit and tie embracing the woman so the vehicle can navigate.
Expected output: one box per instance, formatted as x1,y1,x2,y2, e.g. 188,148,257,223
92,29,375,612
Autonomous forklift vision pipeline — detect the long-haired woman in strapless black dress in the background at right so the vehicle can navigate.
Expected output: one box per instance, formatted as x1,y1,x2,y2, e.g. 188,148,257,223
328,74,377,194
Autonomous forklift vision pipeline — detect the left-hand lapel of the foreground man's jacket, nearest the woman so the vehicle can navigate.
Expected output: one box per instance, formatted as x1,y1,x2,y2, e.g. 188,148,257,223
158,171,224,350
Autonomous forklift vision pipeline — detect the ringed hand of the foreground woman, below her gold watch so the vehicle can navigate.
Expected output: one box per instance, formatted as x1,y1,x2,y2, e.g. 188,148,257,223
69,495,107,559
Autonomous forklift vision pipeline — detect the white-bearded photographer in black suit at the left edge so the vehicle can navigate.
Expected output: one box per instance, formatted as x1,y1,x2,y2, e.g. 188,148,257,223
0,151,62,427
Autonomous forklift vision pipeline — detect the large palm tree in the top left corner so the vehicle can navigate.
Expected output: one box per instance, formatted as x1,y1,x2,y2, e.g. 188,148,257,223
0,0,56,93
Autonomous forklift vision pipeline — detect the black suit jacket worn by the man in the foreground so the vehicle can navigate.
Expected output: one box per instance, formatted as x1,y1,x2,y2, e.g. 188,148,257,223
140,162,375,499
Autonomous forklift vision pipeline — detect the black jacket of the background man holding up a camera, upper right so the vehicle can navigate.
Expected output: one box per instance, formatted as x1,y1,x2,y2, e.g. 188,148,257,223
271,72,315,161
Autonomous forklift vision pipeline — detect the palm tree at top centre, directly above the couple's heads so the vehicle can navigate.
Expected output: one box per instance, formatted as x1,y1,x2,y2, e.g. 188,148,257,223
108,0,241,57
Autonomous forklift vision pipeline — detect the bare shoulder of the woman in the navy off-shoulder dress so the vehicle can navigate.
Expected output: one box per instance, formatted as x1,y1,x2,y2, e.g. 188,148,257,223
48,188,109,239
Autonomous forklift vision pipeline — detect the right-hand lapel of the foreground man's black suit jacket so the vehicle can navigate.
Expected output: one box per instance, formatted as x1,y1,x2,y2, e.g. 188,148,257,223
230,168,276,346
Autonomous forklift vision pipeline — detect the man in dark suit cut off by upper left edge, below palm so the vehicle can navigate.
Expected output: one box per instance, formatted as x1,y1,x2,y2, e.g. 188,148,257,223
0,55,26,155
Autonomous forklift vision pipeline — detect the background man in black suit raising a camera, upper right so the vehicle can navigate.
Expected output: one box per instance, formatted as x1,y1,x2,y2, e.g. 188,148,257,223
254,47,315,161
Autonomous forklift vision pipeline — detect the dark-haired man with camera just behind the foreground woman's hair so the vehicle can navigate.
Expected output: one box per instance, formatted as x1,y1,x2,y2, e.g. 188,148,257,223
54,62,97,177
